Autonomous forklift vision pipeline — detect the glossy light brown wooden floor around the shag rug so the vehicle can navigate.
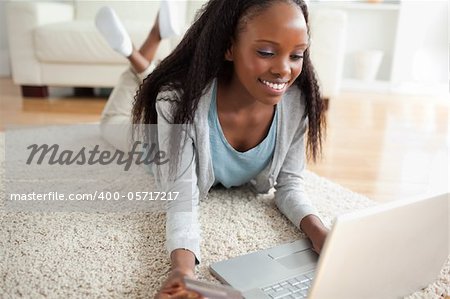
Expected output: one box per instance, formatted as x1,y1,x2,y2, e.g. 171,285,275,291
0,78,450,202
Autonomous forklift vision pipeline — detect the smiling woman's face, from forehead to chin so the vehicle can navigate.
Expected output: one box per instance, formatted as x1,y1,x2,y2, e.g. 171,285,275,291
226,2,308,105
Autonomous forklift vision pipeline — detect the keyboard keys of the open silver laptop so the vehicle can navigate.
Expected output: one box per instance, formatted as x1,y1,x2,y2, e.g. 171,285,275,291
262,271,314,299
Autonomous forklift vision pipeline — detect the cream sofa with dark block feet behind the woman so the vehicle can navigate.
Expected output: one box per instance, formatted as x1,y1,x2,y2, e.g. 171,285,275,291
7,0,346,98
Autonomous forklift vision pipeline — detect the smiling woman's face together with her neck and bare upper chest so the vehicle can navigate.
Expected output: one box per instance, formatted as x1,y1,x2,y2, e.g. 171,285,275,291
217,2,308,151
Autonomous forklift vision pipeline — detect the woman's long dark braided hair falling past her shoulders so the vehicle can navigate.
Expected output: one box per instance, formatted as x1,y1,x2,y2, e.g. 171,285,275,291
132,0,325,161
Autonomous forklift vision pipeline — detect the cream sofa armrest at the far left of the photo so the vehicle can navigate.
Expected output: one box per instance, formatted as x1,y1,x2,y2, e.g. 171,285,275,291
6,1,74,85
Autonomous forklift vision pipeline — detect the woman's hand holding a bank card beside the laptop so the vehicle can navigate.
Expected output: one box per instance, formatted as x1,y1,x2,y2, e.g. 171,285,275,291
155,268,203,299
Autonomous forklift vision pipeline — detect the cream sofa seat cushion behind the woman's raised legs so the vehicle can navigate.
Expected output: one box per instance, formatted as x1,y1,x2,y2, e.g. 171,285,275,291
34,20,170,64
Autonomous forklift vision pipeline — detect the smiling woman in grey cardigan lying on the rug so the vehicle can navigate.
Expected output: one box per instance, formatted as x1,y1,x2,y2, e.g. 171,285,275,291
95,0,328,298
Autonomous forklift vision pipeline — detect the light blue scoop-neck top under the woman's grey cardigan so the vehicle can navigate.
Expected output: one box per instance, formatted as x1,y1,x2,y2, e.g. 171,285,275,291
208,86,278,188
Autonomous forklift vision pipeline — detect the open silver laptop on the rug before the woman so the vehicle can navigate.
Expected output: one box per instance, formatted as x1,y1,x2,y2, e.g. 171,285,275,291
210,193,450,299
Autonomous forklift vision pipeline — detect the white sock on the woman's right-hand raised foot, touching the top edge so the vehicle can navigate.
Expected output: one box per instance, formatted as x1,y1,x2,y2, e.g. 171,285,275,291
159,0,187,39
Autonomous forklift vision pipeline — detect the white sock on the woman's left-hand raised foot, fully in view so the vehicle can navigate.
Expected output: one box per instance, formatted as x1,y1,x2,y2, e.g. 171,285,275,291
95,6,133,57
